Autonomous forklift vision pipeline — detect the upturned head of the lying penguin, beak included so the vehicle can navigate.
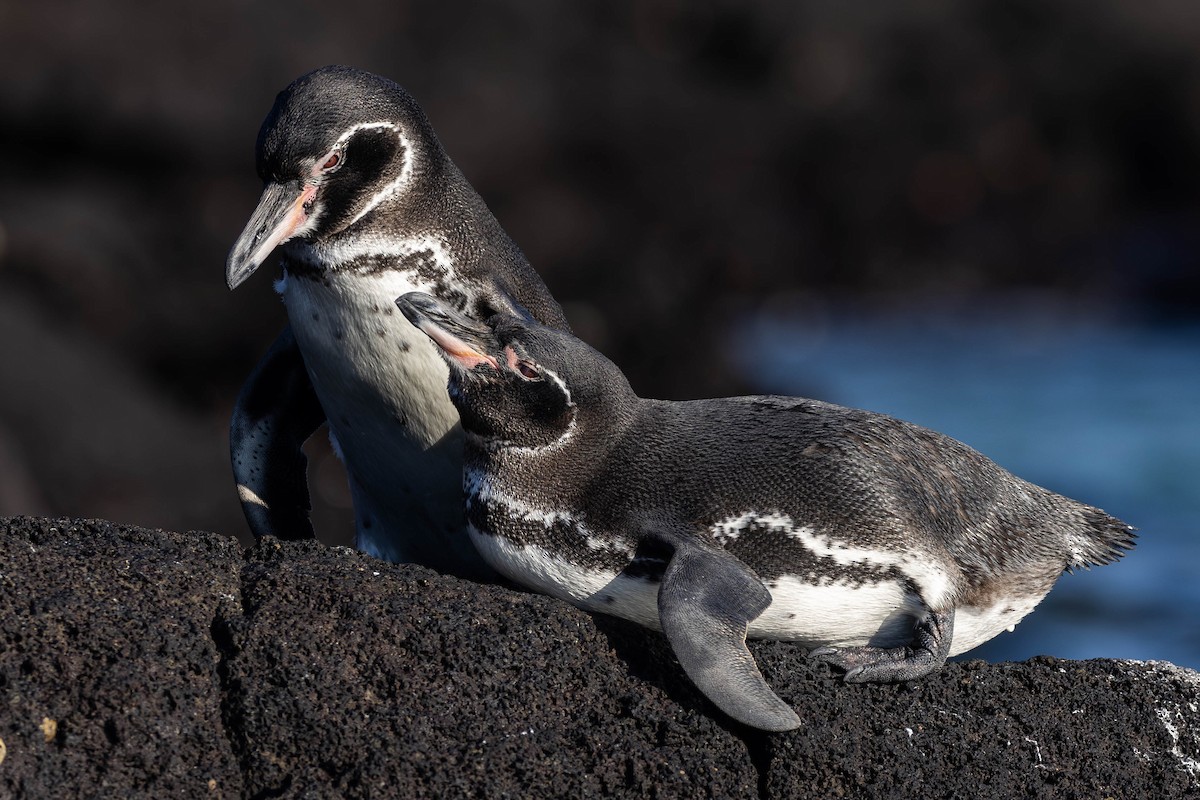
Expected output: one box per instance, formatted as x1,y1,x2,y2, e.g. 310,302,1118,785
396,291,634,450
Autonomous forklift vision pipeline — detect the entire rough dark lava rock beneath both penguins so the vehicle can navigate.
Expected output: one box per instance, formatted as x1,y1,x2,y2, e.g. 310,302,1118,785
0,518,1200,798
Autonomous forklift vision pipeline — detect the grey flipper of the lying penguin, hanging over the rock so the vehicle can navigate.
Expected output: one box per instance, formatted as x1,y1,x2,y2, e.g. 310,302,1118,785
659,541,800,730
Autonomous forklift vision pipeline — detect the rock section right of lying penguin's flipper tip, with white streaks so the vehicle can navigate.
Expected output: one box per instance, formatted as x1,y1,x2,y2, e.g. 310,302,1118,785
767,657,1200,800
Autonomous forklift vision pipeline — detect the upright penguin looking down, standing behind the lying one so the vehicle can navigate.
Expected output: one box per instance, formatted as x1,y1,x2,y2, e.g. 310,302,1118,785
227,66,566,578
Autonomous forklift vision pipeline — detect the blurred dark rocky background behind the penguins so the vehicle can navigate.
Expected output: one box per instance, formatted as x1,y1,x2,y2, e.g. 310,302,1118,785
0,0,1200,556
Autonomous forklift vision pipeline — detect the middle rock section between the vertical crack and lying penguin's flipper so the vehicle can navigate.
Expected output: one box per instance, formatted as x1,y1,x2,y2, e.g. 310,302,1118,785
222,534,757,798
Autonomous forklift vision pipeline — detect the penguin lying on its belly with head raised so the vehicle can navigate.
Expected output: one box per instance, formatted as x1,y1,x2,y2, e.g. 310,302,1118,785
396,293,1134,730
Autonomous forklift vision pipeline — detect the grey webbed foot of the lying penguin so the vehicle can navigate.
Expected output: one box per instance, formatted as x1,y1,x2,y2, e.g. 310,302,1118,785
809,608,954,684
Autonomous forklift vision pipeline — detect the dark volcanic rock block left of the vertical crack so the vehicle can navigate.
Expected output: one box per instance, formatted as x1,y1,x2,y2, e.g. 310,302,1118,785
0,518,242,798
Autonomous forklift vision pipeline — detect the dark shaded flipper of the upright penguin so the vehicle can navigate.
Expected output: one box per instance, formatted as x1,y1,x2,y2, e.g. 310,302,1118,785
229,326,325,539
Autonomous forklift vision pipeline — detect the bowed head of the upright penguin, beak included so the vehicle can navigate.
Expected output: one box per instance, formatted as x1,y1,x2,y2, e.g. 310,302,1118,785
226,66,446,289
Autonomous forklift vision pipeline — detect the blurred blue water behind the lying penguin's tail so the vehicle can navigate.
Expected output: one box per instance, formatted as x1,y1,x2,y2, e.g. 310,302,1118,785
736,306,1200,669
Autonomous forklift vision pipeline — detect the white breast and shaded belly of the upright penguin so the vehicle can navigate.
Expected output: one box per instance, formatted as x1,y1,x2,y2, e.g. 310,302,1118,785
276,270,465,564
